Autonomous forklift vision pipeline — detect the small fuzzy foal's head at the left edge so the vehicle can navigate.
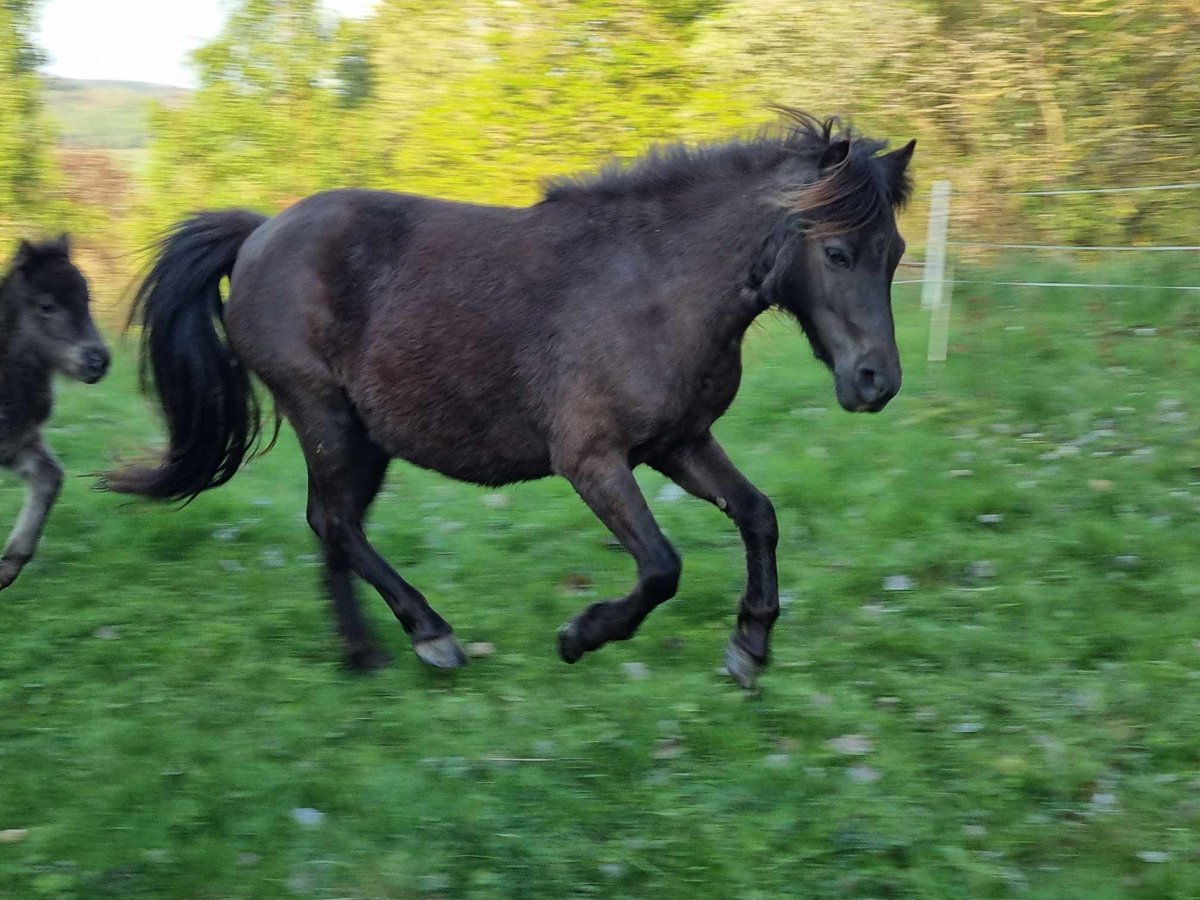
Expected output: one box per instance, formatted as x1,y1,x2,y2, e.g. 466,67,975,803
2,235,109,384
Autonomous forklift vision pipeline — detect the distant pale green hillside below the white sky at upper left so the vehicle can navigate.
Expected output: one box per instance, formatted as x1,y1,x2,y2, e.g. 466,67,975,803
46,78,188,150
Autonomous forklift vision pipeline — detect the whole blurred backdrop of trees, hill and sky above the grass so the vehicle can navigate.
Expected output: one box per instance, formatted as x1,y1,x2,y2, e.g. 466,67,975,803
0,0,1200,321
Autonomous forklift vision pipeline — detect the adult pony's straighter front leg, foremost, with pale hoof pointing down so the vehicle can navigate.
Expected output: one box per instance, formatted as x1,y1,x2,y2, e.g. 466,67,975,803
653,434,779,688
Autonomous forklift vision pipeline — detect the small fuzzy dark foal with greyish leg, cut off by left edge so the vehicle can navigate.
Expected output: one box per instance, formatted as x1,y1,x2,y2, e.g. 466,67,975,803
0,235,108,590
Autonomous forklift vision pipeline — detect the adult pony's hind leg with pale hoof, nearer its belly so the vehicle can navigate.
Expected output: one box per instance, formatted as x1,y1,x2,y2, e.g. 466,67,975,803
277,388,467,668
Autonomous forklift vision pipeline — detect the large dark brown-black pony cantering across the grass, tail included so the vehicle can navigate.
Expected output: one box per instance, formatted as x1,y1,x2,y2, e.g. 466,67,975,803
109,112,913,684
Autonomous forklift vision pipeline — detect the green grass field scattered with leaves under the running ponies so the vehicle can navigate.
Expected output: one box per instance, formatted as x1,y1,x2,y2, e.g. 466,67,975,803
0,266,1200,900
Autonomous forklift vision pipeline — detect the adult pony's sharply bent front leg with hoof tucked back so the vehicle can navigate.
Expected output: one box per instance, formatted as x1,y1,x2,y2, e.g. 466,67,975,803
558,454,680,662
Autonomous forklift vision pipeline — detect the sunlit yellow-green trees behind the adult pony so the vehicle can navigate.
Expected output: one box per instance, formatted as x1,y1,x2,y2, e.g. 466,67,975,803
136,0,1200,247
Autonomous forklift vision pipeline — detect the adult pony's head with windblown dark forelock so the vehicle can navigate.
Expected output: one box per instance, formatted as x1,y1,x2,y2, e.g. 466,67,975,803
763,113,916,413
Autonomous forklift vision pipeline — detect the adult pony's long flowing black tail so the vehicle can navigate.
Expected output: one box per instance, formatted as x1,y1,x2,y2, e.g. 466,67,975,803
104,210,274,502
